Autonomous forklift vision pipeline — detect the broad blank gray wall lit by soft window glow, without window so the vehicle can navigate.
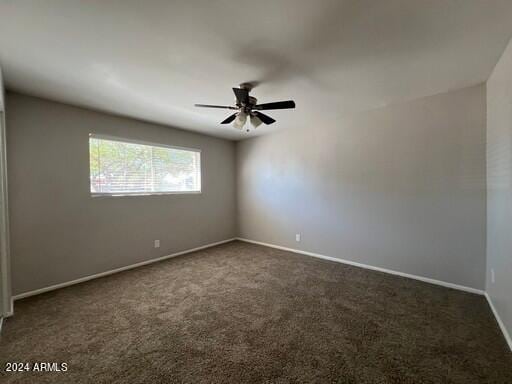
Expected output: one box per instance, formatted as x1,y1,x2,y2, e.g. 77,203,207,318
237,85,486,289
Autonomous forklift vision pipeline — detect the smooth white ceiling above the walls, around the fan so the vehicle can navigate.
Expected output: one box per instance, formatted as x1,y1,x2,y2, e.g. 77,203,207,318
0,0,512,139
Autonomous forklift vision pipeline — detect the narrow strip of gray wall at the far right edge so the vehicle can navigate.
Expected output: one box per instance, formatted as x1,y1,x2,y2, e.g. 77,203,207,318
487,37,512,340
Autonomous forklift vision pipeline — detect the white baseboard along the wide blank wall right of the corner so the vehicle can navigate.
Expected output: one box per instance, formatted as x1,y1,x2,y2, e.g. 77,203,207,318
237,237,485,295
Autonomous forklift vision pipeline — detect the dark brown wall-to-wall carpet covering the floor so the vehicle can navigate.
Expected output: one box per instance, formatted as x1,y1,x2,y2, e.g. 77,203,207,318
0,242,512,384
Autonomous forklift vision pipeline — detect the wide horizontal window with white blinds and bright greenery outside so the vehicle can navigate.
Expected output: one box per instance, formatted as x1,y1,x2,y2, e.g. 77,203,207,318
89,135,201,195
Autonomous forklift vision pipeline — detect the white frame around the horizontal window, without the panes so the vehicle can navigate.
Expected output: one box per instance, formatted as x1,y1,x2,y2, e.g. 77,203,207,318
87,133,203,198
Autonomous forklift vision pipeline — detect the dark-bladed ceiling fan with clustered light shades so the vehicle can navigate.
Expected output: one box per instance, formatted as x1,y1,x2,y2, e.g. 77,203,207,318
194,83,295,132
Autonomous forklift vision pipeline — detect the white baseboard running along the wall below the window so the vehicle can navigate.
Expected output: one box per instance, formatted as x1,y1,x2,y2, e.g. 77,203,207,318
13,238,236,300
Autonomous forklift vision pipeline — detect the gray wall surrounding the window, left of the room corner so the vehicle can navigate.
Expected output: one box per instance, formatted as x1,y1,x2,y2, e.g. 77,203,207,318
7,93,236,294
